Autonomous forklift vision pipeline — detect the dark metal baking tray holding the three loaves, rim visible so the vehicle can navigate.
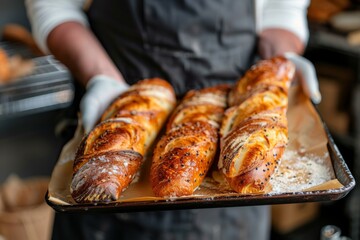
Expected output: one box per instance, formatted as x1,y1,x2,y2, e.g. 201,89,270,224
45,102,355,213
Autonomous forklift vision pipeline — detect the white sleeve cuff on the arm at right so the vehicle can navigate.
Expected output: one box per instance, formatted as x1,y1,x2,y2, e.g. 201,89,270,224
258,0,310,43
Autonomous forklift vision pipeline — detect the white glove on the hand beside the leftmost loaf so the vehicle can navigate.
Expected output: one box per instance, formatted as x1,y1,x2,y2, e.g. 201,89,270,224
80,75,129,133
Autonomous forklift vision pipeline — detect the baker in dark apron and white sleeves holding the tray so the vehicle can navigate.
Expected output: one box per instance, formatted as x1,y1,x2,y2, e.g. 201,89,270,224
26,0,309,240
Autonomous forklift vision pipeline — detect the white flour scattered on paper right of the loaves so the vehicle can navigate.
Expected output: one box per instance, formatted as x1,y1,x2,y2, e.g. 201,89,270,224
270,151,334,193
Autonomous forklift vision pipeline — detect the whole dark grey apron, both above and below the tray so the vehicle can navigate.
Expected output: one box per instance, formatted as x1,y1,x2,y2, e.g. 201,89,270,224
53,0,269,240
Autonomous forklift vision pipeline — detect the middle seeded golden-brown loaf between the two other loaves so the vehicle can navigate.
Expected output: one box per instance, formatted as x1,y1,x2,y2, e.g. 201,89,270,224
150,85,229,197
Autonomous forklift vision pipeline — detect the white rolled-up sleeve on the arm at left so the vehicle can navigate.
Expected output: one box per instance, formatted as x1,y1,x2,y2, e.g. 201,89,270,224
25,0,88,53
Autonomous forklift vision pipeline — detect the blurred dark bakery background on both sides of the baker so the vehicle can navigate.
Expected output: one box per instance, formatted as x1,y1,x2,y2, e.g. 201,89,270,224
0,0,360,240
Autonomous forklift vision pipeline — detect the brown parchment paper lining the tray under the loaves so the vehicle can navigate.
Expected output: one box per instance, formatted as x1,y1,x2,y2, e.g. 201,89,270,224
48,86,342,205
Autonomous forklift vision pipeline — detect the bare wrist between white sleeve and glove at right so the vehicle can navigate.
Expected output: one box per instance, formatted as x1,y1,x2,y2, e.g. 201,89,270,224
258,28,304,59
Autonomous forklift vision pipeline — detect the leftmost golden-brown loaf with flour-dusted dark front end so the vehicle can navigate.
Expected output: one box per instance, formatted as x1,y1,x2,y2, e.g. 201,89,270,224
70,78,176,202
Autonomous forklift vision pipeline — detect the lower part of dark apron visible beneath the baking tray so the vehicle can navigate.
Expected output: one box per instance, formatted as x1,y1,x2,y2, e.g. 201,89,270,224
53,206,270,240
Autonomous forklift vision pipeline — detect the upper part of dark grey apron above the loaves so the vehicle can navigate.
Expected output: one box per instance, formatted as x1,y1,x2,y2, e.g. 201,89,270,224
88,0,256,95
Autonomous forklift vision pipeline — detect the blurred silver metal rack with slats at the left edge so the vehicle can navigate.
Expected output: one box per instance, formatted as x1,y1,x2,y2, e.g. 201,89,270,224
0,42,75,119
